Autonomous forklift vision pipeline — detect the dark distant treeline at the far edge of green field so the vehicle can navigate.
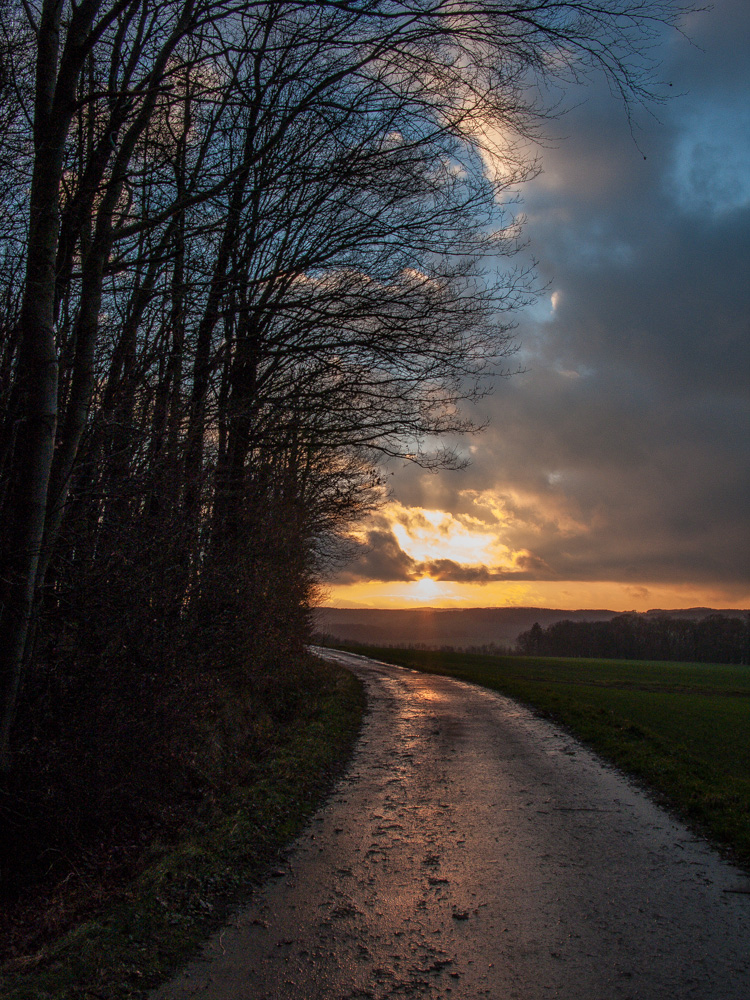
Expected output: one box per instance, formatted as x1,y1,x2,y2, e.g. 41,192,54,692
518,613,750,663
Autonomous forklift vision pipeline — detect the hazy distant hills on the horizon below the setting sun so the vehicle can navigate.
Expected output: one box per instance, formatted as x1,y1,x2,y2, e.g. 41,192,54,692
314,608,747,649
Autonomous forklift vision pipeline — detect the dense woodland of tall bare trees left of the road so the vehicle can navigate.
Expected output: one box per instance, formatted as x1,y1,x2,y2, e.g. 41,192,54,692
0,0,692,916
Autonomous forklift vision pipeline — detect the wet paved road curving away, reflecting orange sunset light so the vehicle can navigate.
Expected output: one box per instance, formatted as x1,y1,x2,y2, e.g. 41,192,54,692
155,650,750,1000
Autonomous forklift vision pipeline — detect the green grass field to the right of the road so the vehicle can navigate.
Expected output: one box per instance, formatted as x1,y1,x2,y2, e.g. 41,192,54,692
346,647,750,867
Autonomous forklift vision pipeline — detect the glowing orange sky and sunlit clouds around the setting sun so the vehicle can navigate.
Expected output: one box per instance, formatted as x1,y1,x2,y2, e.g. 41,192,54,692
324,498,750,611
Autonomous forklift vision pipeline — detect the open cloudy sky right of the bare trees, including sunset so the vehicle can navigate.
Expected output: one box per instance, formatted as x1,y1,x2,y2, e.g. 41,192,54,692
326,0,750,611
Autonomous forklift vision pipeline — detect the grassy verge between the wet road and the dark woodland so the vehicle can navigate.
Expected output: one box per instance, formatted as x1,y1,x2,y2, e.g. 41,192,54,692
0,660,364,1000
